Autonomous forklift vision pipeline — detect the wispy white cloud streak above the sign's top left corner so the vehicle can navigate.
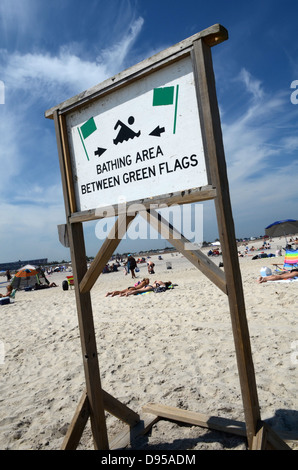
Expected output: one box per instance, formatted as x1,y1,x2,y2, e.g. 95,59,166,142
2,18,144,100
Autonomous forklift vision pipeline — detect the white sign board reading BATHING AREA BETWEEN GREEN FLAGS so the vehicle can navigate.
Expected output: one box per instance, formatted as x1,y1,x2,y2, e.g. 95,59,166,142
66,57,208,211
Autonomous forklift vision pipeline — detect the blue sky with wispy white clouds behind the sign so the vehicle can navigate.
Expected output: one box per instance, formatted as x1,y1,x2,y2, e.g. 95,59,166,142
0,0,298,262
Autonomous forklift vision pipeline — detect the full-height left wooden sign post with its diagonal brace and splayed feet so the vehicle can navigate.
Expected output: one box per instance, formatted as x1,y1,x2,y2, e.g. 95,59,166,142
54,110,152,450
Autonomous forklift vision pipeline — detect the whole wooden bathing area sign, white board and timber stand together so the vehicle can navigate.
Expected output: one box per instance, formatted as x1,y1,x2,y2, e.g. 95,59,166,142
46,25,288,449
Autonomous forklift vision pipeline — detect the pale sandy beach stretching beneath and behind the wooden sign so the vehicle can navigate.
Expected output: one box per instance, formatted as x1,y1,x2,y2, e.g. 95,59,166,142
0,240,298,450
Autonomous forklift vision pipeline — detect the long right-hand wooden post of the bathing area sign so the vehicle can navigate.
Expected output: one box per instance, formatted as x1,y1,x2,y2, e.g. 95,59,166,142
193,39,260,448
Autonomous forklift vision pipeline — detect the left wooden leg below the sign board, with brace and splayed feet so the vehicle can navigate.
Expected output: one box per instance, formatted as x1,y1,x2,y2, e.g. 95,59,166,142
62,216,146,450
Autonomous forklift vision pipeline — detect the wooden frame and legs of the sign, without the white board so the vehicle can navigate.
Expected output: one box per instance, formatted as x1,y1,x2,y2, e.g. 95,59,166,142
45,24,289,450
